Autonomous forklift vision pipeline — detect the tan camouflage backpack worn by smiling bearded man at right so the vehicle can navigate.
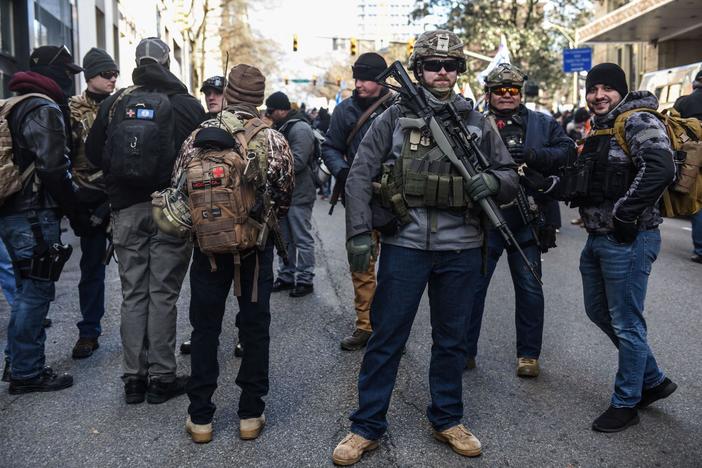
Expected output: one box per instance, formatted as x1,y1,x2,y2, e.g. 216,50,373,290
590,108,702,218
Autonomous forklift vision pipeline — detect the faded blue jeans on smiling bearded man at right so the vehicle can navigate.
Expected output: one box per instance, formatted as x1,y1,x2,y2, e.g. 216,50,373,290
580,229,665,408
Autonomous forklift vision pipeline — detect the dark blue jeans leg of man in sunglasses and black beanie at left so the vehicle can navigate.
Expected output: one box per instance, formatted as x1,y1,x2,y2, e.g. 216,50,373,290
78,231,107,338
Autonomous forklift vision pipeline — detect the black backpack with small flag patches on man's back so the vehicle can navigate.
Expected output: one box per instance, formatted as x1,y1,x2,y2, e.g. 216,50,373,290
104,86,176,187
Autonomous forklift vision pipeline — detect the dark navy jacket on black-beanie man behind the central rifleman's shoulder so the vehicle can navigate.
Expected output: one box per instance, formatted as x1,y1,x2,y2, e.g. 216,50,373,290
322,88,393,176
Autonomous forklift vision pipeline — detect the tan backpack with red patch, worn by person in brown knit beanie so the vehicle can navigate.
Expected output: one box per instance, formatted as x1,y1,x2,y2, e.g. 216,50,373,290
185,118,268,301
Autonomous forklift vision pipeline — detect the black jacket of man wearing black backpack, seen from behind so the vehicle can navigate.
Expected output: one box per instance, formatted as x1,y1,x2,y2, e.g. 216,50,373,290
85,63,207,210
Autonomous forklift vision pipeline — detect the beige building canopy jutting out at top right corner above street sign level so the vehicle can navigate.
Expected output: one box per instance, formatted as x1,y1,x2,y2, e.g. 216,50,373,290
576,0,702,44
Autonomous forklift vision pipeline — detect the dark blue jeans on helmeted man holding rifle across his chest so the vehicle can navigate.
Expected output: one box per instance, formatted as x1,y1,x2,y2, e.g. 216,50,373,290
350,244,481,440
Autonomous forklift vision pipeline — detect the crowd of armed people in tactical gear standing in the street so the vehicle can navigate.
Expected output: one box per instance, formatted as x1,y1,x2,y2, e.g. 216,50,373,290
0,30,702,465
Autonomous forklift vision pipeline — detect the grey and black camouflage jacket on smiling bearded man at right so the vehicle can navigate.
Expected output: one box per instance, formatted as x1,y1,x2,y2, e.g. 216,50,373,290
580,91,675,234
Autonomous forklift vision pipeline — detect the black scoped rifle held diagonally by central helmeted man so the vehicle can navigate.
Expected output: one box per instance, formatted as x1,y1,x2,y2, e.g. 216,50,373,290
374,61,543,284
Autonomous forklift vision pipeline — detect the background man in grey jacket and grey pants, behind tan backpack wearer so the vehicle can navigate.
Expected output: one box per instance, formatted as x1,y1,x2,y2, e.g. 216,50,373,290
266,91,316,297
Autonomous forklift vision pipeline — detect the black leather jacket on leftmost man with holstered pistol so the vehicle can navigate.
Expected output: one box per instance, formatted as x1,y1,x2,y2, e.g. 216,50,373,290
0,97,76,216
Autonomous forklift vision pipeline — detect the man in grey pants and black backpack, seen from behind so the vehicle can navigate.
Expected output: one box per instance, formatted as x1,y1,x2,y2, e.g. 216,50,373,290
85,37,205,403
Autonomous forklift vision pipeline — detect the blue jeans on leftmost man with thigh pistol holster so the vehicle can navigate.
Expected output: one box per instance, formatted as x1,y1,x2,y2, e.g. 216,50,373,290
0,210,61,379
